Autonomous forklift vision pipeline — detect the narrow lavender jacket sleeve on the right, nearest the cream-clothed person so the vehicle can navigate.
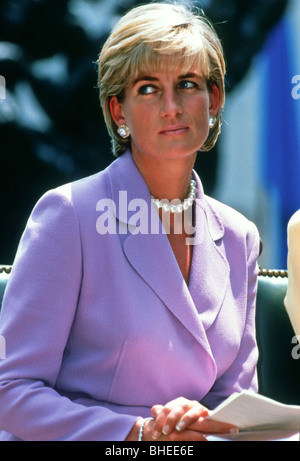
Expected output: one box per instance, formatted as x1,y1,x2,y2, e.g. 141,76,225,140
202,222,260,408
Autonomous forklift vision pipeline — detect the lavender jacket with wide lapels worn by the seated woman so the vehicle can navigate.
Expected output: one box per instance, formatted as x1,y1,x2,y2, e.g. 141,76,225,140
0,152,259,441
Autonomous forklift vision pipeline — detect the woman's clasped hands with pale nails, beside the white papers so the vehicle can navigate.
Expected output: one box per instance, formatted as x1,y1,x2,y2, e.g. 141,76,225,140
143,397,236,441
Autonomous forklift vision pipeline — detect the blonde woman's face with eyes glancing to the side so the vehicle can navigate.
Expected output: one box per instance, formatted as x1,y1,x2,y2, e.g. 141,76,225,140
110,63,219,164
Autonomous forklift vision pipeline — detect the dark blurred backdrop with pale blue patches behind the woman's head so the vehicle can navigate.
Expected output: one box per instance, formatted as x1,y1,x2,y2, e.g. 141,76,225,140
0,0,288,263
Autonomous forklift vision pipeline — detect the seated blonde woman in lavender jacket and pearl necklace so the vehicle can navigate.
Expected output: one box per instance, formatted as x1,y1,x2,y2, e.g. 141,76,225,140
0,3,259,441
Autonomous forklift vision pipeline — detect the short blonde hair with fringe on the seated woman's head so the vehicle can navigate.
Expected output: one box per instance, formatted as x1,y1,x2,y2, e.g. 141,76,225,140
98,3,225,156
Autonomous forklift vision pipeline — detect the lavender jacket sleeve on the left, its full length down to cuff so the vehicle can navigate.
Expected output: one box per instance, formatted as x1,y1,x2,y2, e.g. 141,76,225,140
0,189,137,441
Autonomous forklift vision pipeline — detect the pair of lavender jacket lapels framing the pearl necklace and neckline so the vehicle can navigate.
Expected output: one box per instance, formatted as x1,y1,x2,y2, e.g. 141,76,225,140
109,153,228,354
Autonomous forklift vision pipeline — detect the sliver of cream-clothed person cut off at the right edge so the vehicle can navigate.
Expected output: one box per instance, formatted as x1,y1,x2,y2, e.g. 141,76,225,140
284,210,300,335
